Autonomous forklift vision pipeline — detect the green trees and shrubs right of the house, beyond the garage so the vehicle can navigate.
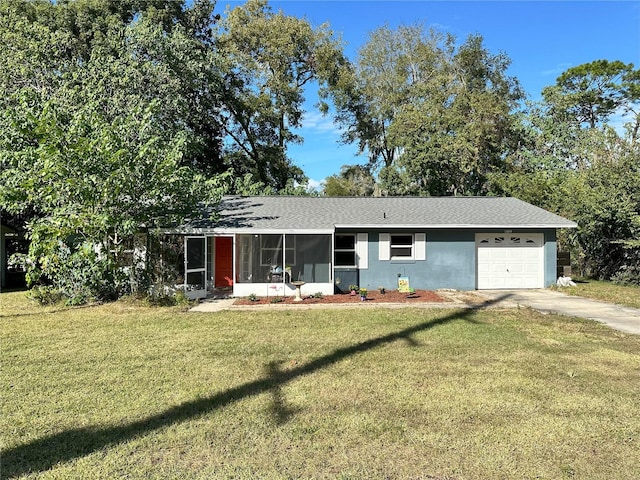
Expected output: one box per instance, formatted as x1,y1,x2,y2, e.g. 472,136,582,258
490,61,640,283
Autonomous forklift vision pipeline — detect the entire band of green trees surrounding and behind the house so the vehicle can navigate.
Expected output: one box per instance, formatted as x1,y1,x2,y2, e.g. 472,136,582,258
0,0,640,302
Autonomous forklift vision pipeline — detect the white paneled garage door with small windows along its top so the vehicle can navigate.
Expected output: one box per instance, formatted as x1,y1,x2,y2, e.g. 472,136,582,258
476,233,544,290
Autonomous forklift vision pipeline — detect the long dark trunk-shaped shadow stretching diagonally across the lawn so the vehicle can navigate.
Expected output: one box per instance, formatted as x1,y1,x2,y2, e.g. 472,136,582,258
0,294,510,478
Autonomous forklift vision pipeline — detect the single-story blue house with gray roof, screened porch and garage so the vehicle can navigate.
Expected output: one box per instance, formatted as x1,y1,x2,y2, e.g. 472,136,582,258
173,196,576,298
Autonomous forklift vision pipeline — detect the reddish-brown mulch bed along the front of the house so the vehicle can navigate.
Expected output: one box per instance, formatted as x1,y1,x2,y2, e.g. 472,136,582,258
234,290,447,305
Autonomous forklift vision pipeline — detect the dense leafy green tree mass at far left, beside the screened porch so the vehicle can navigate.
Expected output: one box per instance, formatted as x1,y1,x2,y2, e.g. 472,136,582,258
0,0,229,301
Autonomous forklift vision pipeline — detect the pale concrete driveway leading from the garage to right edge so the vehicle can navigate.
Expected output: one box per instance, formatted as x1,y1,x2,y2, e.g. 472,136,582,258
477,289,640,335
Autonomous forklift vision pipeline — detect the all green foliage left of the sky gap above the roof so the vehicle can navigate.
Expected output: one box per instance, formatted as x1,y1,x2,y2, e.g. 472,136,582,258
0,0,343,302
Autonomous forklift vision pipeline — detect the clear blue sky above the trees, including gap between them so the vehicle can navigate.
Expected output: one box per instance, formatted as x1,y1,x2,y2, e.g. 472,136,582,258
218,0,640,185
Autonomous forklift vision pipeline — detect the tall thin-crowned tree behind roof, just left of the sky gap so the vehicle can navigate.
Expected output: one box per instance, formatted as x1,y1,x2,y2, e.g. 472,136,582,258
220,0,346,189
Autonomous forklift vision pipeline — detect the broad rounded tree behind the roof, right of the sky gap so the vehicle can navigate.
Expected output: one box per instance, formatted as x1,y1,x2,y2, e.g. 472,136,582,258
335,25,522,195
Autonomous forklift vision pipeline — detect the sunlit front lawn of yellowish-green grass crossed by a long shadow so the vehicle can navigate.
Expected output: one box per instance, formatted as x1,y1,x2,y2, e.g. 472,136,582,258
0,293,640,479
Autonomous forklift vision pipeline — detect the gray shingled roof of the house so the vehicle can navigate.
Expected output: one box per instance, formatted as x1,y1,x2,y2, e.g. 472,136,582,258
180,196,576,233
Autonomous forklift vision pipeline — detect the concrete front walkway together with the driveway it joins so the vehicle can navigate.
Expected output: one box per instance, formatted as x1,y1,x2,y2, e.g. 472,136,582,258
191,289,640,335
